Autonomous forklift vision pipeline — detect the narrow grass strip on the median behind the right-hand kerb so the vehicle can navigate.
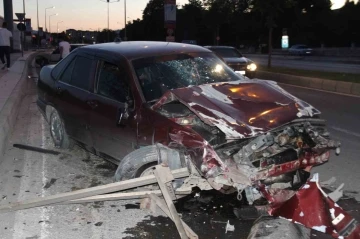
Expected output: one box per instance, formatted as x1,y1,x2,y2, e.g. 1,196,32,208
259,66,360,83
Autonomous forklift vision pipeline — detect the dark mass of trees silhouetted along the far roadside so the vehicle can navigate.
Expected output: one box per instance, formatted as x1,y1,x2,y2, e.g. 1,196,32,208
114,0,360,48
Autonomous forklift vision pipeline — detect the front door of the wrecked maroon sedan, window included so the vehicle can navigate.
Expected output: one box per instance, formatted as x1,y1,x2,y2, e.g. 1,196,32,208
89,59,136,160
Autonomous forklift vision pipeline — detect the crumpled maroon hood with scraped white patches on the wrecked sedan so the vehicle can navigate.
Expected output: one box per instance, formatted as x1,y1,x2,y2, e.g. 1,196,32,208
158,80,320,139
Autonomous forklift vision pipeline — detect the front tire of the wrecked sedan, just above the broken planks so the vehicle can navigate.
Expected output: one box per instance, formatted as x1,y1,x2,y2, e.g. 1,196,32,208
115,145,158,182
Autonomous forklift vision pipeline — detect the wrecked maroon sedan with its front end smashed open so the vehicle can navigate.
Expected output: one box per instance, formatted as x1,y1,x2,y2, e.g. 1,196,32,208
38,42,358,238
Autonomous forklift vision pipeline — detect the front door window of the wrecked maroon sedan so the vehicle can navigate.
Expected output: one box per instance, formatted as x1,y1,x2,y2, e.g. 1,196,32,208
97,62,131,103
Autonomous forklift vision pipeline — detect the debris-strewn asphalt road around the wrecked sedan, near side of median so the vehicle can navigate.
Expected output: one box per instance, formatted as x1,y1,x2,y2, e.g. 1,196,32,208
0,62,360,239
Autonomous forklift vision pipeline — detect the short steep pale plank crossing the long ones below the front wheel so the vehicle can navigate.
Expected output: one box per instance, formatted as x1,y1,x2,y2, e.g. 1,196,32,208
154,165,188,239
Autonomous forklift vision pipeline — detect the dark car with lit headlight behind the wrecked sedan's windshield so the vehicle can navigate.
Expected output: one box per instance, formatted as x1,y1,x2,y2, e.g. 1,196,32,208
205,46,257,78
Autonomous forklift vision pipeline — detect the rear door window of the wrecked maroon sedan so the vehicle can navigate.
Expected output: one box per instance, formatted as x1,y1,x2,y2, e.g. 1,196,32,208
70,56,94,90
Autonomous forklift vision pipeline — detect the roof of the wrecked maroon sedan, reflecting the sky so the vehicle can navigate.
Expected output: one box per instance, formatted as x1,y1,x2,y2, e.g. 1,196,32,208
79,41,211,60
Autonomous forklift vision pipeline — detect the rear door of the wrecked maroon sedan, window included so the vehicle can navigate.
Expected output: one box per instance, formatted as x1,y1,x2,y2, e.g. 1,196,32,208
54,53,96,146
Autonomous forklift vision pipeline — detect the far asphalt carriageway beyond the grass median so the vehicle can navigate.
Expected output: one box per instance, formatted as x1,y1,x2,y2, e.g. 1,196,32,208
246,55,360,74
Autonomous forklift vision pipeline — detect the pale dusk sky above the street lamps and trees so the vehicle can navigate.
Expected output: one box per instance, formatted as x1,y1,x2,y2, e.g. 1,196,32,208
0,0,356,32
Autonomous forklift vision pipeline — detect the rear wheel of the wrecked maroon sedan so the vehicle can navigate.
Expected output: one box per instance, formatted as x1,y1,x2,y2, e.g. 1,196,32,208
49,109,74,149
